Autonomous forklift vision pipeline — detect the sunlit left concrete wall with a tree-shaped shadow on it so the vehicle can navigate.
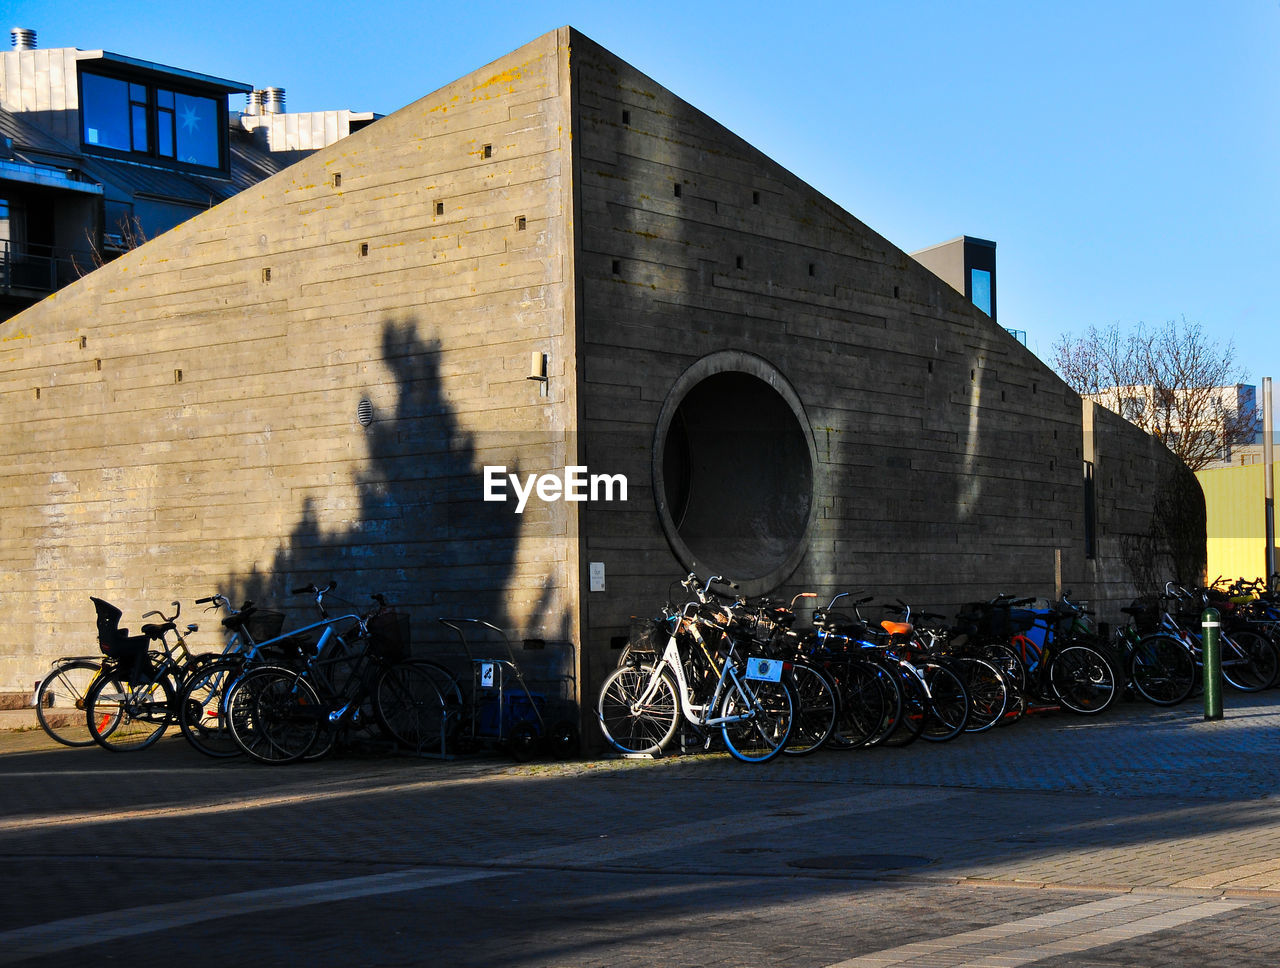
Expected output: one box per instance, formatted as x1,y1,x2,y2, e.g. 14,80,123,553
0,33,577,690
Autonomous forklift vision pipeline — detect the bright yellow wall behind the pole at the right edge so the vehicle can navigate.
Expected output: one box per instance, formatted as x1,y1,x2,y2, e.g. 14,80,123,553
1196,464,1266,581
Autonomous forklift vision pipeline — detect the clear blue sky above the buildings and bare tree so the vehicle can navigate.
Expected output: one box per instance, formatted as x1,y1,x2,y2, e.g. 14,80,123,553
12,0,1280,393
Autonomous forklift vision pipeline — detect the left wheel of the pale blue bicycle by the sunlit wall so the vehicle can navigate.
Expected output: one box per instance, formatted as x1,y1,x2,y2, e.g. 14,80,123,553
227,666,324,763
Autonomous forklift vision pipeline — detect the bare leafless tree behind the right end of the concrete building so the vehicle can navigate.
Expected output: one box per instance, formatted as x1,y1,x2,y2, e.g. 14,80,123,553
1050,319,1258,471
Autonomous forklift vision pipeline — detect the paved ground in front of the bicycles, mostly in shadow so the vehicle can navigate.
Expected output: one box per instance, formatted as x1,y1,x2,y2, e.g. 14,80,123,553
0,691,1280,968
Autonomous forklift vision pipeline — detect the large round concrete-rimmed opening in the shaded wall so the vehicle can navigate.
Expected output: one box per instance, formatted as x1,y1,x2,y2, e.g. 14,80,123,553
653,352,815,594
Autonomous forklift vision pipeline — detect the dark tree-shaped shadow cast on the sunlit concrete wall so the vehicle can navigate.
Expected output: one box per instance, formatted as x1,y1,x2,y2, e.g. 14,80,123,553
233,320,568,681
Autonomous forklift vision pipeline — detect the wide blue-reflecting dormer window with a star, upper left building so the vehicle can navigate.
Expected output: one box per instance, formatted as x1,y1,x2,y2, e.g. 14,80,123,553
81,70,227,169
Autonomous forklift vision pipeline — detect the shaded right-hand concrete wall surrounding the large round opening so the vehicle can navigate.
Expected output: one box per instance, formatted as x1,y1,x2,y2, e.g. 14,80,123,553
573,37,1178,671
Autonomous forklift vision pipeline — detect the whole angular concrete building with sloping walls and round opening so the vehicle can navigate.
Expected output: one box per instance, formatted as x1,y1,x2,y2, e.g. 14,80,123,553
0,28,1203,717
